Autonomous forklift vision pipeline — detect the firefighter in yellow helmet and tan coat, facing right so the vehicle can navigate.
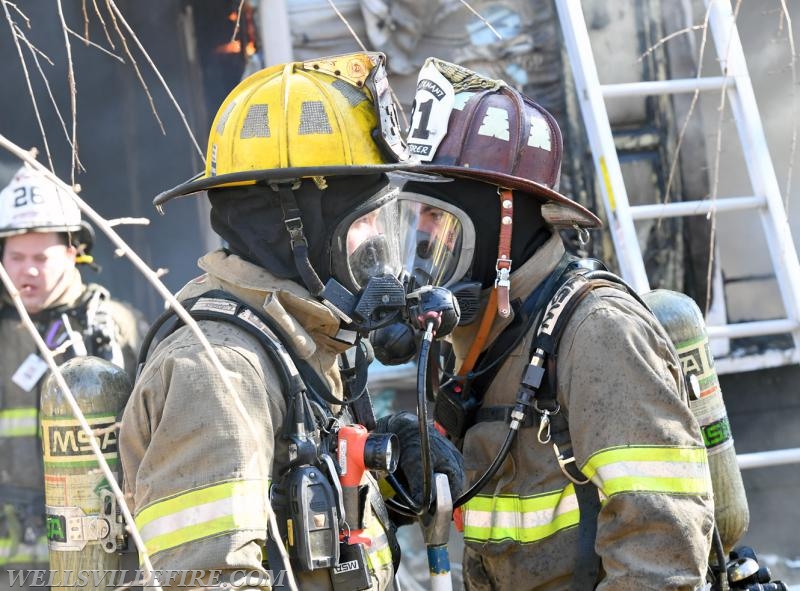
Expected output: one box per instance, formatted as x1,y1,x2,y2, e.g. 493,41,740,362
120,53,462,589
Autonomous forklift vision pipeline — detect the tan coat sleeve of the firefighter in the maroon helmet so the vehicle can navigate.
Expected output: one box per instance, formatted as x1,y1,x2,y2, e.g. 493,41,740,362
558,292,713,591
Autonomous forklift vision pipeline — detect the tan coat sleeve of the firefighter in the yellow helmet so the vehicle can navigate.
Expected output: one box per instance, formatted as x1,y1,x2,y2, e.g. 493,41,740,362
120,323,284,579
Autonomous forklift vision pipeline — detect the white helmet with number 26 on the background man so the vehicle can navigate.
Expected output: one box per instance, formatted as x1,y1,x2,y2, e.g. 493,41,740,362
0,166,83,237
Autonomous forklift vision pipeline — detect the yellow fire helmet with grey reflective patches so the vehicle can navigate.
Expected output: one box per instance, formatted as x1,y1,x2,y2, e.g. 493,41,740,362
153,53,407,208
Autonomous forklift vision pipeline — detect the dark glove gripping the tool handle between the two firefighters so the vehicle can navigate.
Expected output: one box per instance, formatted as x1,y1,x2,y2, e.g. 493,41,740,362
375,411,464,504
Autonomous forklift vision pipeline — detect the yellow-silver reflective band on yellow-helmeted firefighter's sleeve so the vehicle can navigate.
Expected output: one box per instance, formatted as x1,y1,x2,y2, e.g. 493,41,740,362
135,480,269,554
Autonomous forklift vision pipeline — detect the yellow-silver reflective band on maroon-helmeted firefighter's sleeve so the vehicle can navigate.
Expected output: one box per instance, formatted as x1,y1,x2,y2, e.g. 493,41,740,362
581,446,711,497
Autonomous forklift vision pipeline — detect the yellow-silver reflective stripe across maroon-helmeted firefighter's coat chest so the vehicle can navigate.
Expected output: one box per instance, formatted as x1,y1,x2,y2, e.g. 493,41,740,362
464,484,580,543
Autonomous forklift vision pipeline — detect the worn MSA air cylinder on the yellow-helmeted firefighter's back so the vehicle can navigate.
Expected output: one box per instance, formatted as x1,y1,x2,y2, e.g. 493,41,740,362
40,356,131,590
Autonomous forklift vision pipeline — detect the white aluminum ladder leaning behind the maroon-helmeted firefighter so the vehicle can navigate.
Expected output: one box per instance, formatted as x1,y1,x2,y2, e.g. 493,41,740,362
556,0,800,373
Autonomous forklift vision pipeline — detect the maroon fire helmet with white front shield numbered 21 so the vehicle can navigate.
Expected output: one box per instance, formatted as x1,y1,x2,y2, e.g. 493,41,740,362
408,58,601,227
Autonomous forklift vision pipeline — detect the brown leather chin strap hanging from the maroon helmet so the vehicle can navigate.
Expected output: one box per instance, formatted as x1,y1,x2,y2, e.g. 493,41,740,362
458,187,514,377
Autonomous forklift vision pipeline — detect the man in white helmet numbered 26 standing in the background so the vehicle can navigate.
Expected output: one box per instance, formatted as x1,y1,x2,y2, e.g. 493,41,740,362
0,166,141,584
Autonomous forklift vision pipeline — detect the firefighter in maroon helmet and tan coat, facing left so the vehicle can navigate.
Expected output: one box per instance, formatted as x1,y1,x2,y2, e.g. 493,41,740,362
400,59,714,591
